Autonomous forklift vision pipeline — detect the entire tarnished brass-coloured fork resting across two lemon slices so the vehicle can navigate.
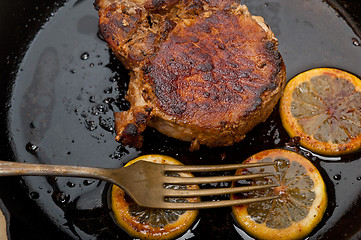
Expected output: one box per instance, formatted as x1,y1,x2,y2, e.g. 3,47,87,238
0,161,277,209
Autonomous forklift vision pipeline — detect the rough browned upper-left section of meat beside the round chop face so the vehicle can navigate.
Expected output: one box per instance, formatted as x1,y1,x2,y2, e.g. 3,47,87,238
95,0,242,69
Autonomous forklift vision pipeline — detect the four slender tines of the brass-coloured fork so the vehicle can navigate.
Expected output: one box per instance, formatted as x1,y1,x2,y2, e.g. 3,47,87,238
160,163,278,209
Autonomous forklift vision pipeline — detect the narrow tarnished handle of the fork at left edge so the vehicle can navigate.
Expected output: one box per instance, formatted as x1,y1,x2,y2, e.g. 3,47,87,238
0,160,109,181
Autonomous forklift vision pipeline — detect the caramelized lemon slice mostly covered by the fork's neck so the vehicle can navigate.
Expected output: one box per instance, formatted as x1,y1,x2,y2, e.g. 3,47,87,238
111,155,198,240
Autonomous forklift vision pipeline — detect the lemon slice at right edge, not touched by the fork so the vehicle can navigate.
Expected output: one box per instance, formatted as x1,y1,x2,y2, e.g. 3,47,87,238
280,68,361,155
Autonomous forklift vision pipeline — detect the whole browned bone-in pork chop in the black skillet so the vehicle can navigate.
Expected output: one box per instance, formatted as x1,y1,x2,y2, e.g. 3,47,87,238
96,0,286,150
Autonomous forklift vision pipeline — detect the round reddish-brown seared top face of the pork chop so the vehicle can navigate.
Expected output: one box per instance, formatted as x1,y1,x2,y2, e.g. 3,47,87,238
143,11,283,129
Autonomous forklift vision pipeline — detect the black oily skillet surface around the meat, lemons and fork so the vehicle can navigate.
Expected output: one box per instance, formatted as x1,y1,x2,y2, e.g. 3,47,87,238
0,0,361,240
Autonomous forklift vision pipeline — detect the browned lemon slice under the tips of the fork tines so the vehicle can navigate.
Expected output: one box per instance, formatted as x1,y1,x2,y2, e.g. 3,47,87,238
231,149,327,240
